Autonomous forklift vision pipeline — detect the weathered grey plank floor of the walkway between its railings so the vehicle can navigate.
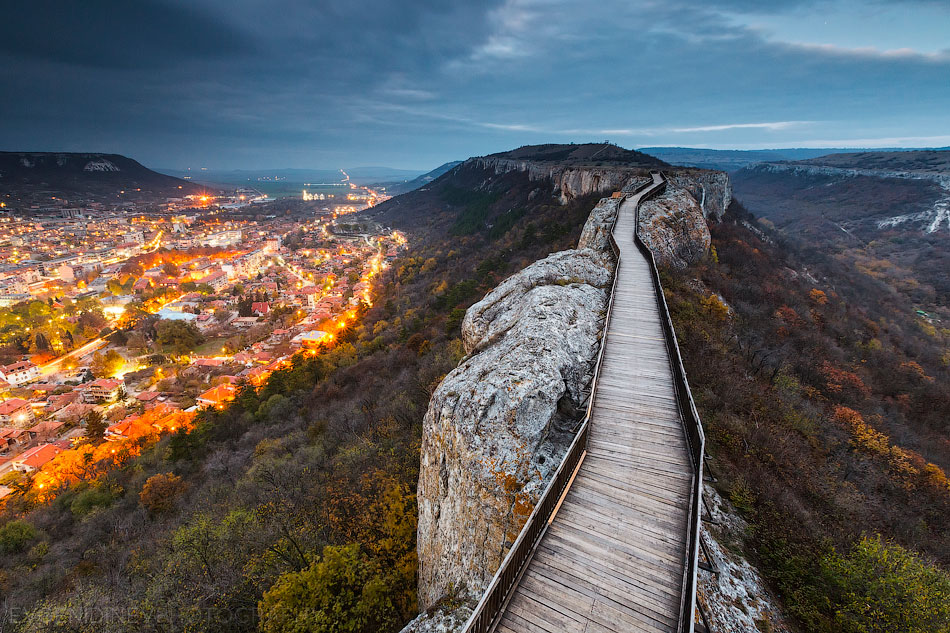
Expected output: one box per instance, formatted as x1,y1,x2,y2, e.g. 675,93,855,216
495,175,693,633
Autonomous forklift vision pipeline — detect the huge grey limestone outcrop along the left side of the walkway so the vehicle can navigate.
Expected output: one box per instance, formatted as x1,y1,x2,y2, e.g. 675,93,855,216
418,199,619,608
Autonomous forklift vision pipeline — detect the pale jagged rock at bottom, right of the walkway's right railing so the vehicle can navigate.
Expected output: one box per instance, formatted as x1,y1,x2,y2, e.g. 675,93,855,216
697,486,792,633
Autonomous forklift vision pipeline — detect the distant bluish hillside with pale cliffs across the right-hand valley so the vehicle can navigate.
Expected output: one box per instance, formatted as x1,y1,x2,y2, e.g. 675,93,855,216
732,150,950,310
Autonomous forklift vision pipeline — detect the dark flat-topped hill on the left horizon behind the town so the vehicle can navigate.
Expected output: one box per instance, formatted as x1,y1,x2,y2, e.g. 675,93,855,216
0,152,204,202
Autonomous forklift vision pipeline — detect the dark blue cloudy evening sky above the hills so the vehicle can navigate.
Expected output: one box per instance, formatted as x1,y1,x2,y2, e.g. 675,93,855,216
0,0,950,170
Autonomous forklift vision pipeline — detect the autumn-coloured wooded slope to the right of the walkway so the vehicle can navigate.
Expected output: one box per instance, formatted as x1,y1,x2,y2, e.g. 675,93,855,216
664,203,950,632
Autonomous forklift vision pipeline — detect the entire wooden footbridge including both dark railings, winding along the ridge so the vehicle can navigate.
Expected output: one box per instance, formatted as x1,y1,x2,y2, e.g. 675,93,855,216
465,174,705,633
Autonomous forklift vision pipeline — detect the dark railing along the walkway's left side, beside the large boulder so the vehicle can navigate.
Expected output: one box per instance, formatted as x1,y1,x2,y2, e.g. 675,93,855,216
462,188,640,633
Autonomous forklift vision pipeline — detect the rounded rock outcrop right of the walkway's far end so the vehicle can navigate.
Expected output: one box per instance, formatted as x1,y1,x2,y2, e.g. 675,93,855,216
640,183,711,268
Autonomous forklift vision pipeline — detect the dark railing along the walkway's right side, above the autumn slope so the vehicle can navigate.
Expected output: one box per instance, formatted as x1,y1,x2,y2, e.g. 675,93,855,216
634,173,706,633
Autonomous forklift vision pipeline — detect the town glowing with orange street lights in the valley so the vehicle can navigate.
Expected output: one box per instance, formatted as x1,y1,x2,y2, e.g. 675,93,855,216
0,184,406,498
